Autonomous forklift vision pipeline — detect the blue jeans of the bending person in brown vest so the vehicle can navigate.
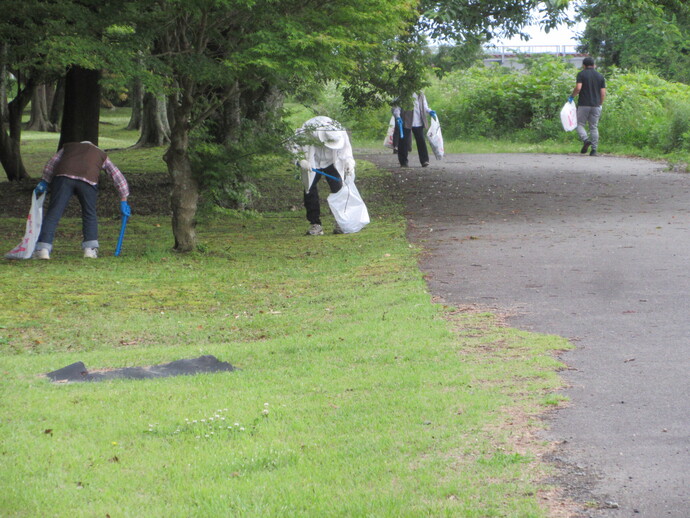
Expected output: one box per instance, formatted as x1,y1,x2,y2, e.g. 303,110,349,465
36,176,98,251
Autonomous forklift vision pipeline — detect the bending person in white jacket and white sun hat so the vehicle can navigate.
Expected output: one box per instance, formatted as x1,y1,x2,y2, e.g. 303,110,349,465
293,115,355,236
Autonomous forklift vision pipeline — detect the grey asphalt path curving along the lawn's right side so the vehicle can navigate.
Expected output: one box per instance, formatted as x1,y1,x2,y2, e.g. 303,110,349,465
363,149,690,518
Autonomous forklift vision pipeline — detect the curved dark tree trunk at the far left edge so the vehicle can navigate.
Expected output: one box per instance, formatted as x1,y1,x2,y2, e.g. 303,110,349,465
0,80,36,182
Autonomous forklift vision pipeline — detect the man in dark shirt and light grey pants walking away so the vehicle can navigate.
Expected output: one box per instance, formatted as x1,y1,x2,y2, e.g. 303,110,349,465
568,57,606,156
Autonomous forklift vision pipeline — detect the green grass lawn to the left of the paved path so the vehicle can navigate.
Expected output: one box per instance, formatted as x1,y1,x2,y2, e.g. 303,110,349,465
0,108,568,517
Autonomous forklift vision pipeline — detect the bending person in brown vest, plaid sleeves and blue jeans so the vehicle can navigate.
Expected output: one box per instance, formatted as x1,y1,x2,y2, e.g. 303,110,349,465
34,141,132,259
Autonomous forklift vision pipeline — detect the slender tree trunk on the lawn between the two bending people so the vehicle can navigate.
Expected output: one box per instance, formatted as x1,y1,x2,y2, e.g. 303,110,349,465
163,84,199,252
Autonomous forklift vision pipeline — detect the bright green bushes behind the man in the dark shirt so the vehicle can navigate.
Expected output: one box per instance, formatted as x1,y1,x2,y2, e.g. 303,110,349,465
420,56,690,153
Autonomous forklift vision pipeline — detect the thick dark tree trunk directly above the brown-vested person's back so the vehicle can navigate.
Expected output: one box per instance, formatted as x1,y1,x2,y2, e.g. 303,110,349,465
58,66,101,148
